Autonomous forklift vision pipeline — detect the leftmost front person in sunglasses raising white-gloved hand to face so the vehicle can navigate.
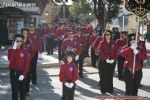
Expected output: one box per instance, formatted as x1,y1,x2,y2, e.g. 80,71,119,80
8,34,30,100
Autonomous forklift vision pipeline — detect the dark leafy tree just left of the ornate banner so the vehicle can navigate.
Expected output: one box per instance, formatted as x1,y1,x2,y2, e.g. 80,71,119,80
93,0,122,29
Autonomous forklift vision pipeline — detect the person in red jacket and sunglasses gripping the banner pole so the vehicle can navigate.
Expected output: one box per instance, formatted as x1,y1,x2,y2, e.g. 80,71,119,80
120,34,147,96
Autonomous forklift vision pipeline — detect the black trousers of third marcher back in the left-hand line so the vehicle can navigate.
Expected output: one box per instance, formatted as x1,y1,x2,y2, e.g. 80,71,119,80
30,52,38,83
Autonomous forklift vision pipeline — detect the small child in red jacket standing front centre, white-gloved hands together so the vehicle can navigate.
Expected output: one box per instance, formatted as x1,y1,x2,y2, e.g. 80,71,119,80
59,52,78,100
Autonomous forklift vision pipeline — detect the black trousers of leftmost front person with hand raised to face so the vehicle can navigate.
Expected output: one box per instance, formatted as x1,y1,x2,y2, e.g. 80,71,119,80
10,70,26,100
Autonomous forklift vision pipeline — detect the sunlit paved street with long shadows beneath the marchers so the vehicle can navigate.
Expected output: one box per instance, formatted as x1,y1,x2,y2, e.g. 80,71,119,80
0,45,150,100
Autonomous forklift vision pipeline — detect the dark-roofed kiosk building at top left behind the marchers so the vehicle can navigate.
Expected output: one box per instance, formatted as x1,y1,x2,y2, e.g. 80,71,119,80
0,0,40,43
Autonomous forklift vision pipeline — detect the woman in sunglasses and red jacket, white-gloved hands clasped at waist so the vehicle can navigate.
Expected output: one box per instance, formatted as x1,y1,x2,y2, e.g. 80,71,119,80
98,30,118,94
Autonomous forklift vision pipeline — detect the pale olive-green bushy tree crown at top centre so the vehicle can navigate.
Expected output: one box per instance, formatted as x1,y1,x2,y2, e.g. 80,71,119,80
69,0,93,23
